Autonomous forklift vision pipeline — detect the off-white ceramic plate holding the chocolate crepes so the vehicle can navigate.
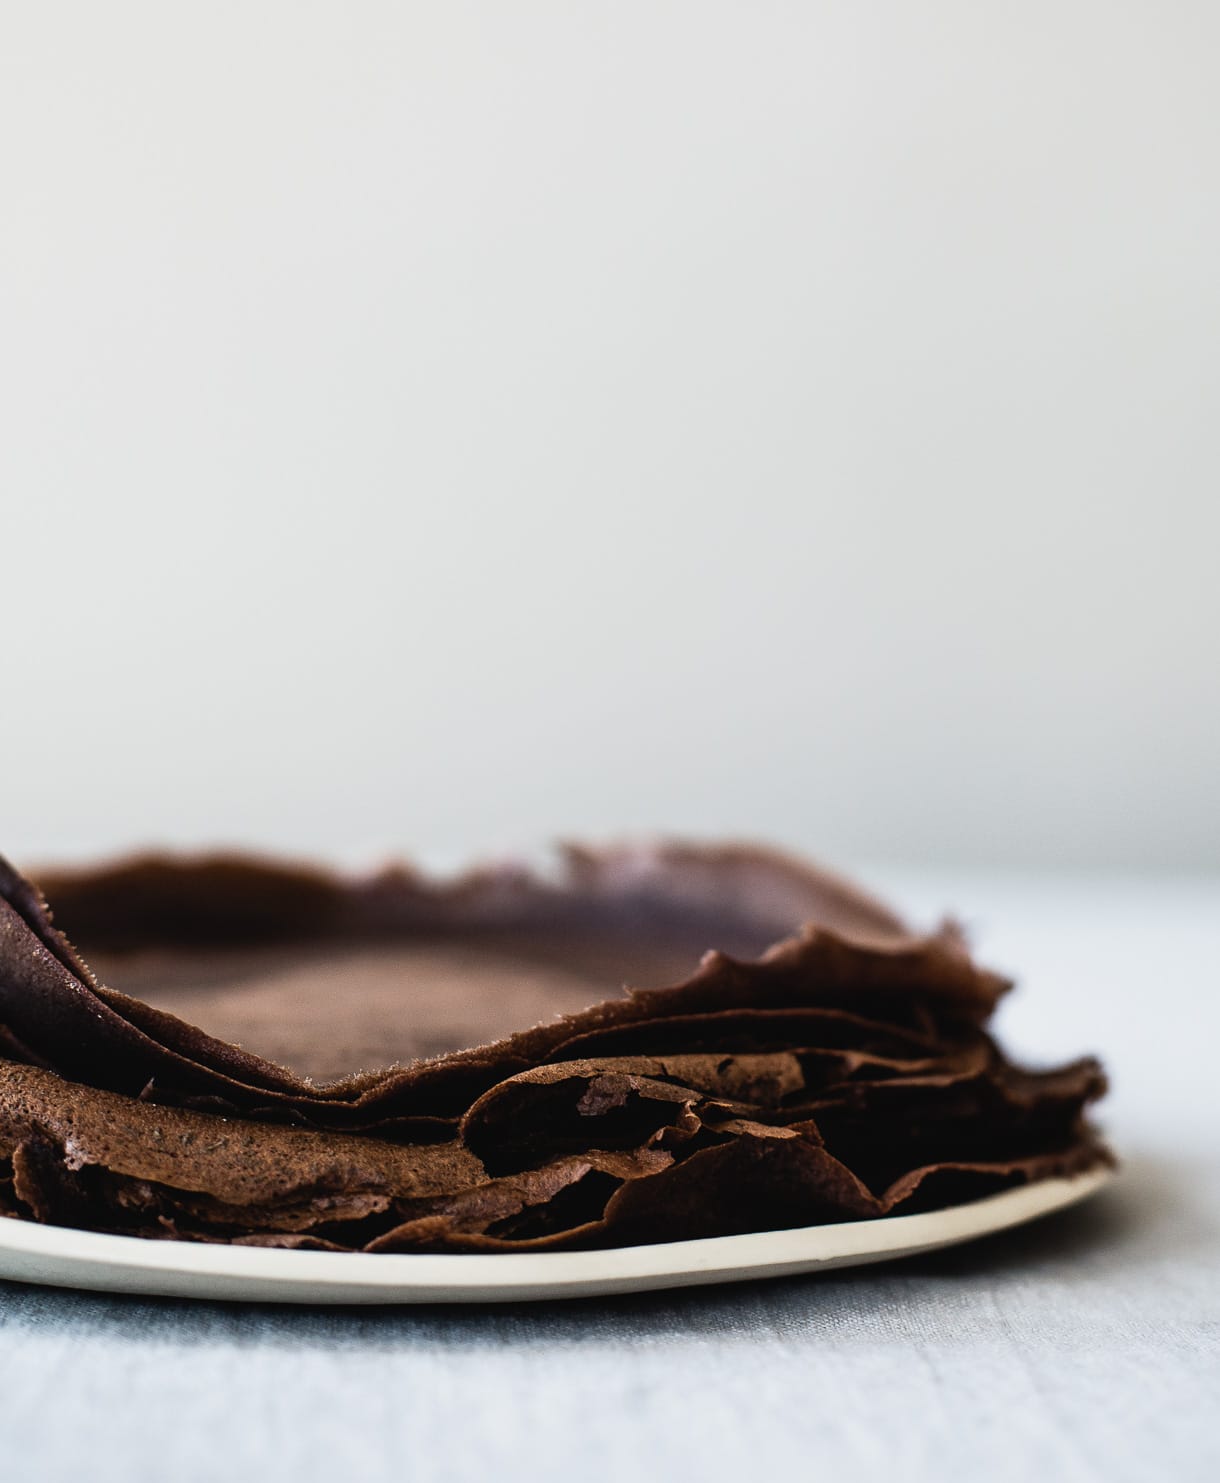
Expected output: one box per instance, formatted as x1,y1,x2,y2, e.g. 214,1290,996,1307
0,1169,1112,1304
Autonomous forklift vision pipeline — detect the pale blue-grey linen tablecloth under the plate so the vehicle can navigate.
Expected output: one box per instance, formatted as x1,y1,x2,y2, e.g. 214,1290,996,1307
0,872,1220,1483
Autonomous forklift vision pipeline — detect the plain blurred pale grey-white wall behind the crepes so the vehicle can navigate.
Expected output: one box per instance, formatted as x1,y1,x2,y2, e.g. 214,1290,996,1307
0,0,1220,866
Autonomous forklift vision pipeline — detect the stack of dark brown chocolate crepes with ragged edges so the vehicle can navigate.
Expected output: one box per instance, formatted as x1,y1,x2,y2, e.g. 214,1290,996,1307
0,845,1110,1252
